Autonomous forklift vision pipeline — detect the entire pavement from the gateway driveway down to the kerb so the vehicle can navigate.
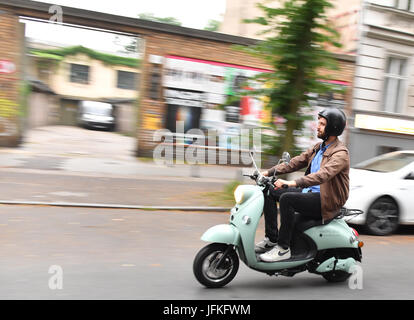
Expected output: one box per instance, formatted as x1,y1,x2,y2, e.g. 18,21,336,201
0,126,251,210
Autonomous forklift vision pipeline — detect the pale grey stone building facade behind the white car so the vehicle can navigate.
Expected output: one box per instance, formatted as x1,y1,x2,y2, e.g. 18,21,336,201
349,0,414,164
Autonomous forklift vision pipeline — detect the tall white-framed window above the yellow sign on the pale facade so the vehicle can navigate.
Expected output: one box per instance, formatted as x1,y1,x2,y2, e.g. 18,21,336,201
383,57,407,113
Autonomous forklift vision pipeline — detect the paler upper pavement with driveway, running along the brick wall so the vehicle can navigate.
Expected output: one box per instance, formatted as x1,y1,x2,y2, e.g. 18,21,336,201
0,126,246,181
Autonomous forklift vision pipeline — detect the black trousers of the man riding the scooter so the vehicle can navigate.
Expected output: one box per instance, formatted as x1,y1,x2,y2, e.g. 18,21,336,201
263,188,322,249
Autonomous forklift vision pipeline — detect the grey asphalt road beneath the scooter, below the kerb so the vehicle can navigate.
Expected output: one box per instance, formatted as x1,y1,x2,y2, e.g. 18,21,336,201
0,205,414,300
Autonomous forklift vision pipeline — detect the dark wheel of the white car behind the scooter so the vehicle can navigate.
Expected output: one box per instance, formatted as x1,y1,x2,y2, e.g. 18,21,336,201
366,197,399,236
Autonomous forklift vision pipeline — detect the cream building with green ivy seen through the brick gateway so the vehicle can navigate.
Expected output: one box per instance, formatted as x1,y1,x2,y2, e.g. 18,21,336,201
25,40,140,134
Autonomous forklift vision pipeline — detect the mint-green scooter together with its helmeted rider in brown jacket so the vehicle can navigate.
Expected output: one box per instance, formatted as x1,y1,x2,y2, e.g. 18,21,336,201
193,105,364,288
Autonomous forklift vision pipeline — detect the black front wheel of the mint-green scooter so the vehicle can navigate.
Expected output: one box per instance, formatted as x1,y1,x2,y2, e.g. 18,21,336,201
193,243,239,288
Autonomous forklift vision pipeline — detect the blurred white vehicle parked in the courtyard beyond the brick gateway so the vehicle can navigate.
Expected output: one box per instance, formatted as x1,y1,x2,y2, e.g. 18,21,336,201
79,101,115,131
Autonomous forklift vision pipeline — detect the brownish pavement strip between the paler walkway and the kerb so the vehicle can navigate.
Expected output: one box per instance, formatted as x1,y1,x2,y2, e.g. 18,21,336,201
0,168,228,207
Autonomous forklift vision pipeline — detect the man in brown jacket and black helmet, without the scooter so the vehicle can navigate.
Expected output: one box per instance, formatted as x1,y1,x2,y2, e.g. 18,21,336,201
255,108,350,262
